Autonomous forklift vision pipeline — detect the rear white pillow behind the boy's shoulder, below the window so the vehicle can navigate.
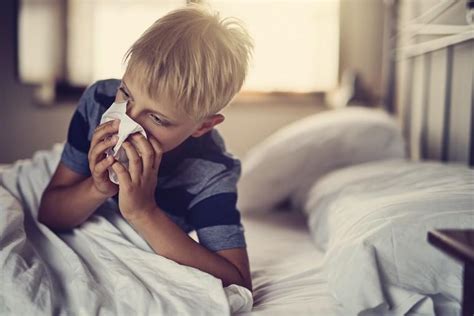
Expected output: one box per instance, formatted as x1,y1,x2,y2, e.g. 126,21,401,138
238,107,405,211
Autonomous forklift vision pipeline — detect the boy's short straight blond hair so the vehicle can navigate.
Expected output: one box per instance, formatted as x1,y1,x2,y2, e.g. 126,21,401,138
124,4,253,120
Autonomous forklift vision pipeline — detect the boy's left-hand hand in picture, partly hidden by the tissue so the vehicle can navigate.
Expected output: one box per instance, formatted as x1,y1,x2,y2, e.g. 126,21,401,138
88,120,120,197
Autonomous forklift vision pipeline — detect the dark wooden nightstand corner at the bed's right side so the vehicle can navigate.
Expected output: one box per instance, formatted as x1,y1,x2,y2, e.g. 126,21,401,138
428,229,474,316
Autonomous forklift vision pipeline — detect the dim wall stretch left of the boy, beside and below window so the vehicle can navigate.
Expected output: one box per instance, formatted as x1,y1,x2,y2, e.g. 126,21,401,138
0,0,74,163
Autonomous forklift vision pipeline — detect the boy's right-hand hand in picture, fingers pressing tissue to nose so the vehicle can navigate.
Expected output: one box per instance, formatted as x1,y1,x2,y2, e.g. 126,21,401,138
112,133,163,221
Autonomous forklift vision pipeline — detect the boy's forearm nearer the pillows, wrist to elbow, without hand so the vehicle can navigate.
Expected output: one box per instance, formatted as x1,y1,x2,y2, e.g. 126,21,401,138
129,207,252,291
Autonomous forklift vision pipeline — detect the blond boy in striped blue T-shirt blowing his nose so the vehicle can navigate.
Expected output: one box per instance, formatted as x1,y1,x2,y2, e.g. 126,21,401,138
39,6,252,291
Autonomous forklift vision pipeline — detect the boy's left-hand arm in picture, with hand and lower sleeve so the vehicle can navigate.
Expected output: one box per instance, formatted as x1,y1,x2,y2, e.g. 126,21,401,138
38,114,119,230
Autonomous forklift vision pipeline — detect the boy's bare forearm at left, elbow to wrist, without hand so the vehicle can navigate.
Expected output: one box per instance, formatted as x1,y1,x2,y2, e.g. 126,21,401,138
38,162,108,230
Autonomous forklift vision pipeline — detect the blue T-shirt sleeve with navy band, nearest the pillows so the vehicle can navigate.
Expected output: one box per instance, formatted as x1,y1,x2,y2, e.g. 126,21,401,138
189,159,246,251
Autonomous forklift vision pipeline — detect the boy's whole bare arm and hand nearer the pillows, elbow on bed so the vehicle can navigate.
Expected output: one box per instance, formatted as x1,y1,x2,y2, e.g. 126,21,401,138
112,134,252,291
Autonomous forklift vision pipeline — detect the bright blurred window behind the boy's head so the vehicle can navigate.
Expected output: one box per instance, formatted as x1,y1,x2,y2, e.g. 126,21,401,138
19,0,339,102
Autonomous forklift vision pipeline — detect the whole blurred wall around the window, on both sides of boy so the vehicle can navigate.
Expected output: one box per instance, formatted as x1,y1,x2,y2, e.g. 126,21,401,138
0,0,383,163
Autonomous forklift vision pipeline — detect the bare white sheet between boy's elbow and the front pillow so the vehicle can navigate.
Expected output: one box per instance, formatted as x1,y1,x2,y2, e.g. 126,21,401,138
237,209,343,316
